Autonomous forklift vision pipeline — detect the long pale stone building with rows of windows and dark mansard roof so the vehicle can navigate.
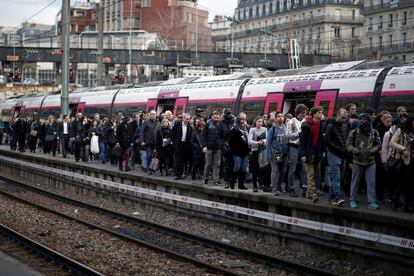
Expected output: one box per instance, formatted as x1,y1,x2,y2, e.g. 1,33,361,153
232,0,363,60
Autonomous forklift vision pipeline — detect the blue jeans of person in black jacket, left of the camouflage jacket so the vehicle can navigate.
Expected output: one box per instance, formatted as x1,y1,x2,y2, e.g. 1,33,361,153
325,151,345,199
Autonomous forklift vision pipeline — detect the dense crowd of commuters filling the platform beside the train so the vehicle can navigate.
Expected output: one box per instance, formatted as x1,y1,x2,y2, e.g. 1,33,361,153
0,104,414,212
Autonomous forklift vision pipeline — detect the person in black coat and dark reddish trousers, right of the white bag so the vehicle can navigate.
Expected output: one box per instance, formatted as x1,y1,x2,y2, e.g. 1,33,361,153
116,116,134,171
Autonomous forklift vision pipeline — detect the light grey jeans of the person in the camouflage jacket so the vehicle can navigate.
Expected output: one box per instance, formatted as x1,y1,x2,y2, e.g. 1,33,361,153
350,163,377,203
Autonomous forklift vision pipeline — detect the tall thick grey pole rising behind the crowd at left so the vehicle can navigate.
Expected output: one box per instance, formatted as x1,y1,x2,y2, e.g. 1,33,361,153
61,0,70,116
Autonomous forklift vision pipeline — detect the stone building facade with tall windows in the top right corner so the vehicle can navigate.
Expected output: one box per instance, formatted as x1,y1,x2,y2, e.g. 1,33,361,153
360,0,414,62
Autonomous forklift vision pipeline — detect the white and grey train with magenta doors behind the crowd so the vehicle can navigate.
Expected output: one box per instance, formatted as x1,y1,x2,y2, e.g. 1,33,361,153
0,65,414,121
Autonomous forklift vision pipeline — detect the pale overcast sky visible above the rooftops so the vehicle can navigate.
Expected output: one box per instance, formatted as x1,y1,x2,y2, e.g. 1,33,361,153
0,0,237,27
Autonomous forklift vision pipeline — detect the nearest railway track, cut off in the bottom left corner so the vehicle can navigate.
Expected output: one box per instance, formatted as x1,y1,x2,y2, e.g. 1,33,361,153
0,223,103,276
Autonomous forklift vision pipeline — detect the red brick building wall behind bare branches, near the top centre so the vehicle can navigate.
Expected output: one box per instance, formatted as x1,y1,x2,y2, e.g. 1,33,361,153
141,0,212,51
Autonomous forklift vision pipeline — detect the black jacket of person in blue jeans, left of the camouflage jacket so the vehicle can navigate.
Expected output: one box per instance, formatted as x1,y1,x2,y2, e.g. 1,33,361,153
325,121,349,158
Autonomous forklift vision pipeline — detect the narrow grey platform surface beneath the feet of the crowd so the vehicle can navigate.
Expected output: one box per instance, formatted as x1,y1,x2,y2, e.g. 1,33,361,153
0,145,414,227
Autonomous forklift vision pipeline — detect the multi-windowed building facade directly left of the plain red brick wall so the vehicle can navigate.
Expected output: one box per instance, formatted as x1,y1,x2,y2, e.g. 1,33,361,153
101,0,141,32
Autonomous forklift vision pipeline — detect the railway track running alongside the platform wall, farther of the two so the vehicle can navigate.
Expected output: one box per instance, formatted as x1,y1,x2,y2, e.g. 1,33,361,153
0,181,332,275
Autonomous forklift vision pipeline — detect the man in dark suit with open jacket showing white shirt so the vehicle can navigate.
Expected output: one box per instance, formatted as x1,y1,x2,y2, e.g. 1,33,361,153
171,113,193,180
